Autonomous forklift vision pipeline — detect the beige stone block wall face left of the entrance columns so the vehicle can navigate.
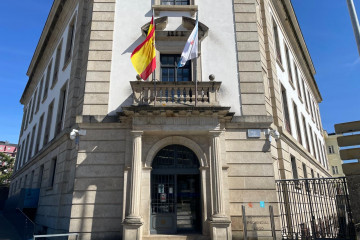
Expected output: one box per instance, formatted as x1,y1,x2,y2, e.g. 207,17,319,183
69,124,127,239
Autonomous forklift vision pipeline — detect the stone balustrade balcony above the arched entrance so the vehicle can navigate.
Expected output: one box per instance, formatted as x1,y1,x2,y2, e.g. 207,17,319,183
130,81,221,107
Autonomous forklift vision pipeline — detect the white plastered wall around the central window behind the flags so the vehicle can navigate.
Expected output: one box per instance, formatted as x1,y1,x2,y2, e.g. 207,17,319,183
108,0,240,115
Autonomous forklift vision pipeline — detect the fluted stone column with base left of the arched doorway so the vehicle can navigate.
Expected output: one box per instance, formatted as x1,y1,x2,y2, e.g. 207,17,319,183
123,131,143,240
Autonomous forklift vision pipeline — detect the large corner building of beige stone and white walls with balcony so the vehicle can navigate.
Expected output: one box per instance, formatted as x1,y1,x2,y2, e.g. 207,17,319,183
9,0,330,239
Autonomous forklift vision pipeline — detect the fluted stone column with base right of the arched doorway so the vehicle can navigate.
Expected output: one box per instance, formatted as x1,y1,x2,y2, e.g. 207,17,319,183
209,131,231,240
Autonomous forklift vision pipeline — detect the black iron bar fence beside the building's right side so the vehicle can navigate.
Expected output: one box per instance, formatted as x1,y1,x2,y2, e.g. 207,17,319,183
276,177,356,239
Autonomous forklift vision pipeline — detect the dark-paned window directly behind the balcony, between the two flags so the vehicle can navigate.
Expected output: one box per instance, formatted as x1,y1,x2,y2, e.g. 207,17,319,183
160,54,191,82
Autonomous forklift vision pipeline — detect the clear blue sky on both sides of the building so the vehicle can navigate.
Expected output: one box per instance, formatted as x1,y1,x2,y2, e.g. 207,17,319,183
0,0,360,143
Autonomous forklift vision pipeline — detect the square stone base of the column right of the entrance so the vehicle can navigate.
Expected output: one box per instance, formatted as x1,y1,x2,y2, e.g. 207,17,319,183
210,216,232,240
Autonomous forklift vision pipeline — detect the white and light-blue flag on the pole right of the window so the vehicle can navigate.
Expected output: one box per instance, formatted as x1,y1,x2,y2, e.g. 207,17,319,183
178,16,199,68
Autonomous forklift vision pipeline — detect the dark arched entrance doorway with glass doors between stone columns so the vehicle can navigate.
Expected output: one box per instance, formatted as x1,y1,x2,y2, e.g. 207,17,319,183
150,145,201,234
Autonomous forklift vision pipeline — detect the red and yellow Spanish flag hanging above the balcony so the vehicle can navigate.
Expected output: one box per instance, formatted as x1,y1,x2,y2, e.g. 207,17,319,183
131,16,156,80
